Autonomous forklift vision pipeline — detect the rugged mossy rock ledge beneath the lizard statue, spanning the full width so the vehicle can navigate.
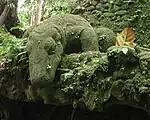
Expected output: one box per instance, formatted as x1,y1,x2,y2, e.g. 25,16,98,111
0,46,150,109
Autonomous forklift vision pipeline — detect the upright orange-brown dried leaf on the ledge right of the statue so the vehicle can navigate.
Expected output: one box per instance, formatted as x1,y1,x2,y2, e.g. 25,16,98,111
120,26,135,43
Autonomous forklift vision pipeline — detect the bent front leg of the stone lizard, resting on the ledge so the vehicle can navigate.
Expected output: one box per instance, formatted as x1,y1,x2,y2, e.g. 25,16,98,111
66,26,99,52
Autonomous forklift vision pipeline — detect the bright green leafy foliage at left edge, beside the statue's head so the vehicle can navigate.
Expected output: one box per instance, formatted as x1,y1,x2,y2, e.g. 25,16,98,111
0,27,26,59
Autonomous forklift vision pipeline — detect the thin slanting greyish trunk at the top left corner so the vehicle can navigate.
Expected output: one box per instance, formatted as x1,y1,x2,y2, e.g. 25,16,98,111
0,5,10,26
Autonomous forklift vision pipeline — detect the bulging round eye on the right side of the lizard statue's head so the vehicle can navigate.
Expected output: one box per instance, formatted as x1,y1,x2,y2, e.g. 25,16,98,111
44,39,56,55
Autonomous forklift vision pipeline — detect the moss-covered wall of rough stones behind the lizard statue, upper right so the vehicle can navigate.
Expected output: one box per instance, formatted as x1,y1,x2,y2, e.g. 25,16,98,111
72,0,150,47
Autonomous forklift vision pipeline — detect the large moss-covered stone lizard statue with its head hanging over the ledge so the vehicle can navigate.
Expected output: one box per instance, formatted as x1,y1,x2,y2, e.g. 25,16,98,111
27,14,99,90
